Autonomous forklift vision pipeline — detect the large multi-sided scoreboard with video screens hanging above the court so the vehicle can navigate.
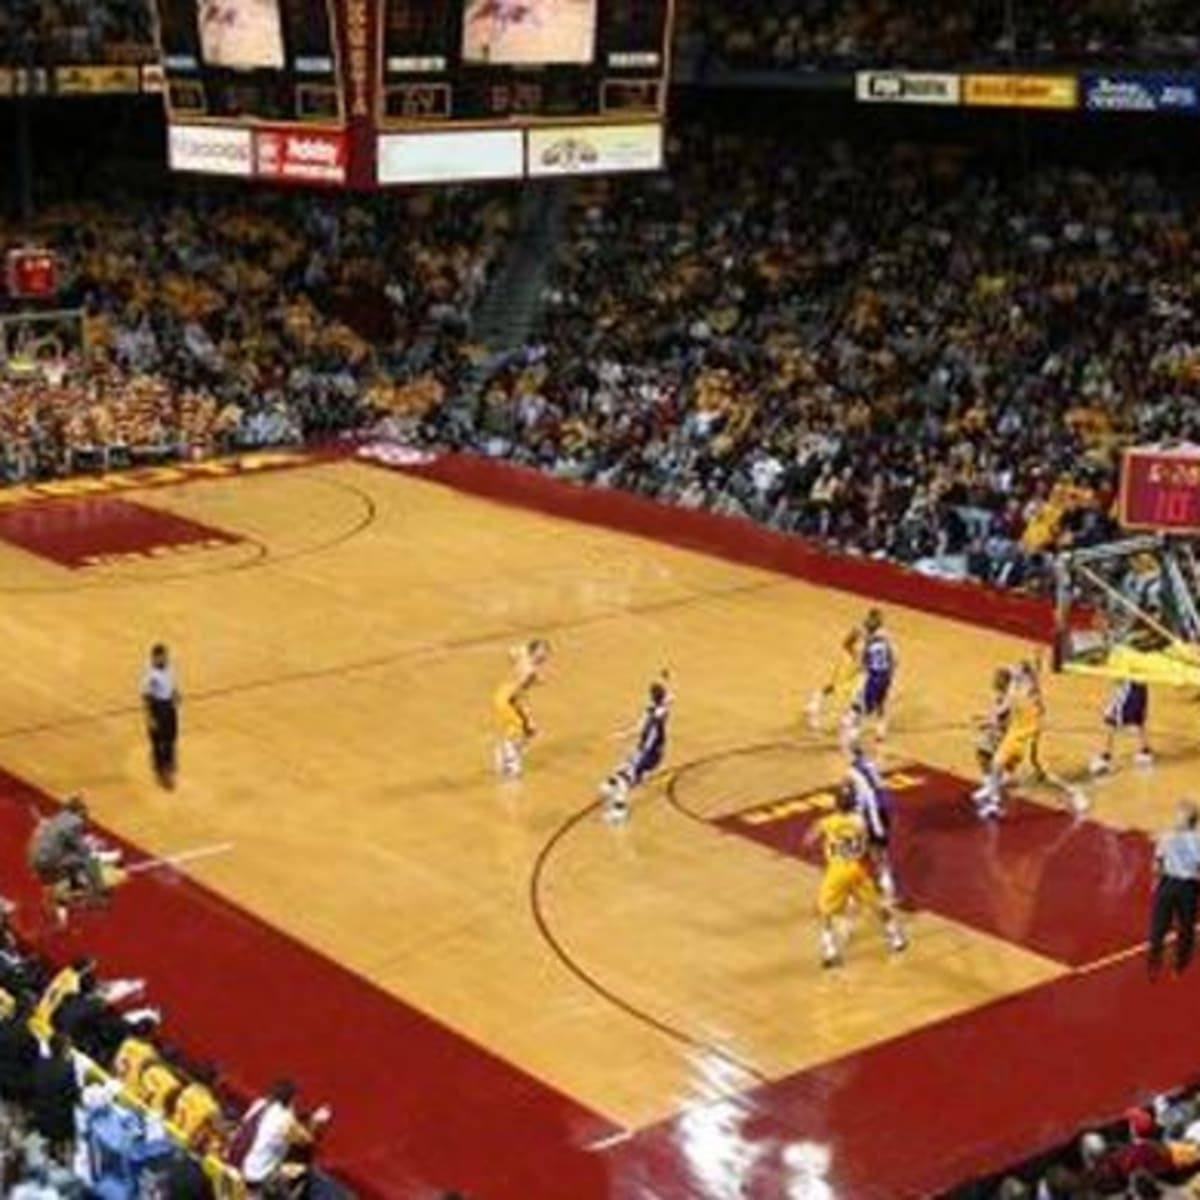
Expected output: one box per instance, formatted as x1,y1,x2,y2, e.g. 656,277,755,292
146,0,673,187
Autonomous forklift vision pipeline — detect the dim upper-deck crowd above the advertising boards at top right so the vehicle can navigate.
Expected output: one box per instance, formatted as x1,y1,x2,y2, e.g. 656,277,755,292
682,0,1200,70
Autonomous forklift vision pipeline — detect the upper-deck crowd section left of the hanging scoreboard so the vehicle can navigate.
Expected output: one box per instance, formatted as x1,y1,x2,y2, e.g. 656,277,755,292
0,0,155,66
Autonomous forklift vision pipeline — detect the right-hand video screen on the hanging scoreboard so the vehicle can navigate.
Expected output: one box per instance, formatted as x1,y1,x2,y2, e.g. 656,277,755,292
462,0,598,66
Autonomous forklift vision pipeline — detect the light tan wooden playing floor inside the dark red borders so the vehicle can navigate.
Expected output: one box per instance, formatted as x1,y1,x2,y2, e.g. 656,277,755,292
0,462,1200,1129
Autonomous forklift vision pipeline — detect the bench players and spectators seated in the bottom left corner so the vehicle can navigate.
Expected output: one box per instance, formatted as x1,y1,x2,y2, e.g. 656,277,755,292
0,902,330,1200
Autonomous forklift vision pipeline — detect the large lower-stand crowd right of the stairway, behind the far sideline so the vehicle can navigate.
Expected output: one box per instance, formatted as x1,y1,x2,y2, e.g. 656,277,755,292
424,136,1200,584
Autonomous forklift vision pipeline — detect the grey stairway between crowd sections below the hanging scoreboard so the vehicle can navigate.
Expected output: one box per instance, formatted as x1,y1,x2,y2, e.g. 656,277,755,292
472,181,569,354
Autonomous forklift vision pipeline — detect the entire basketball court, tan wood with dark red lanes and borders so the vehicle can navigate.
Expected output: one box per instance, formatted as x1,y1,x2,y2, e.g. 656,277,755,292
0,455,1200,1200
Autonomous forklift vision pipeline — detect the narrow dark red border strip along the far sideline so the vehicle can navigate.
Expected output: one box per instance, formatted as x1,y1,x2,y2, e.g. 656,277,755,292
388,454,1054,644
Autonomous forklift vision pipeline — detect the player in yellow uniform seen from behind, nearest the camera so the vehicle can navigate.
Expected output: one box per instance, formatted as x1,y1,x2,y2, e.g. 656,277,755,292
805,784,908,967
